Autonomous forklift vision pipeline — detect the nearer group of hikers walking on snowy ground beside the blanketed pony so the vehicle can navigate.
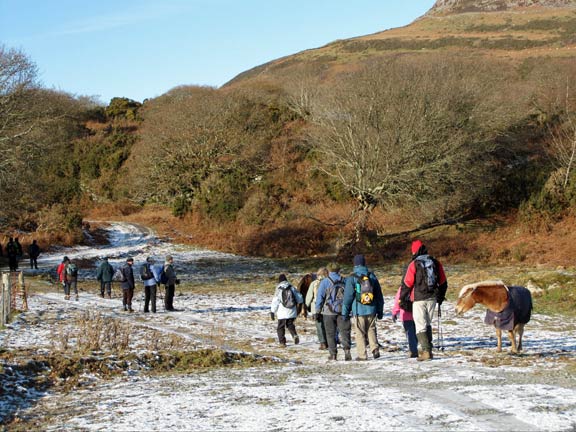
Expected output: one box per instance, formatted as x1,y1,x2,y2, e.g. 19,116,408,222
270,240,448,361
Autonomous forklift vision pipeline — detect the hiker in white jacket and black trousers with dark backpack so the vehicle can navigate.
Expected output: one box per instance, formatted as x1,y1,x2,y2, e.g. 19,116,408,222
270,274,304,347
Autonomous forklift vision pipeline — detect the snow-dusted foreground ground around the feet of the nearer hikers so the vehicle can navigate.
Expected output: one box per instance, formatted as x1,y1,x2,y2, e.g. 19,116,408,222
0,286,576,431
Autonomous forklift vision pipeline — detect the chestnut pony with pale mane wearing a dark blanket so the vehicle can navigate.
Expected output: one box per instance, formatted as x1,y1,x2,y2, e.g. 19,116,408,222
456,280,532,354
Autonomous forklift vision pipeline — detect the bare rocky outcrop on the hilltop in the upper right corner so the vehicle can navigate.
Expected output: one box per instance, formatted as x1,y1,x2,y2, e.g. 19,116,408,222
428,0,576,15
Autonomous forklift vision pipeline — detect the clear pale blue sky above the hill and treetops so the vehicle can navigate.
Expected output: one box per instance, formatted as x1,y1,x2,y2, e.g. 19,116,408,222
0,0,435,104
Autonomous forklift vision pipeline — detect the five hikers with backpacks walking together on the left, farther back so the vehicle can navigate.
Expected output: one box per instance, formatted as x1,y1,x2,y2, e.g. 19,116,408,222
56,255,180,313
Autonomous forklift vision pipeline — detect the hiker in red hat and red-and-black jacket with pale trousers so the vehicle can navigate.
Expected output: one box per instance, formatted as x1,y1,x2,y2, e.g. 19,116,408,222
399,240,448,361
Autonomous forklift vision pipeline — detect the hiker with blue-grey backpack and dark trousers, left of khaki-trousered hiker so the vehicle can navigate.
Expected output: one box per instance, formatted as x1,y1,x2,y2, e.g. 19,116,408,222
315,263,352,361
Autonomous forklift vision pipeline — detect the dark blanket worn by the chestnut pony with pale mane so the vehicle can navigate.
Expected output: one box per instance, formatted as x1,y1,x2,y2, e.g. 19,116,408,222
484,286,532,330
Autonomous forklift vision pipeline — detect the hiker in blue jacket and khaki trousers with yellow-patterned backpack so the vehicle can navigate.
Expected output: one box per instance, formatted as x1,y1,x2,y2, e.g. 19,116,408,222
342,255,384,361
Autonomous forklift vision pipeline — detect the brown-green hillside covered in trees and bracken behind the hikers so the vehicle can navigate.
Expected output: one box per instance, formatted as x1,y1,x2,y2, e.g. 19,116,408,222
0,8,576,260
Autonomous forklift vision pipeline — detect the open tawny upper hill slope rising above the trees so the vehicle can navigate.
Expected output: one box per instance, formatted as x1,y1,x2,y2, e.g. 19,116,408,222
227,0,576,85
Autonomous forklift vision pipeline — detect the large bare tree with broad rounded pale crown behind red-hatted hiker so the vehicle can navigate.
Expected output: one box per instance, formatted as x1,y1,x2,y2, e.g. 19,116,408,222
313,57,516,235
